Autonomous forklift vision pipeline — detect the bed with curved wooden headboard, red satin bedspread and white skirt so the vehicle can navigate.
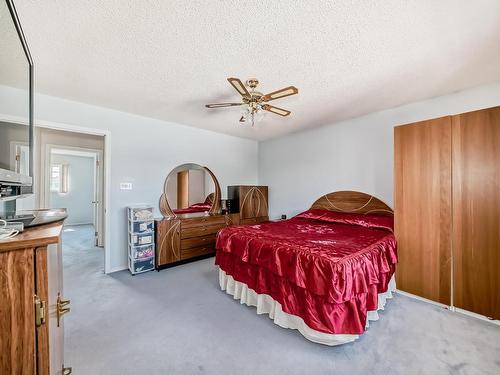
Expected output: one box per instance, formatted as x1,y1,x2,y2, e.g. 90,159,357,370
215,191,397,346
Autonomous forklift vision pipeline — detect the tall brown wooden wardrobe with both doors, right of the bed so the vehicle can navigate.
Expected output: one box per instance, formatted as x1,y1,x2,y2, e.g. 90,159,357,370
394,107,500,319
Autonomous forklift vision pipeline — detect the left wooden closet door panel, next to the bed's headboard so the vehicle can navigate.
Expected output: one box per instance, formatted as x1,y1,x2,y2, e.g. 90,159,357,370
394,116,451,305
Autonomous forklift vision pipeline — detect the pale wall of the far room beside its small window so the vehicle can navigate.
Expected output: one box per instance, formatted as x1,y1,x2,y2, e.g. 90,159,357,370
50,154,95,225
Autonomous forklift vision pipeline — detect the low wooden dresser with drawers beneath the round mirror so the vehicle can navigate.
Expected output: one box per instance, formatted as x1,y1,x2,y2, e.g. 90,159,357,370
155,213,239,269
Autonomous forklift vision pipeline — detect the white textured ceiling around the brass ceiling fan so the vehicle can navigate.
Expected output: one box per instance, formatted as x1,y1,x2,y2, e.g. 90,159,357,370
8,0,500,140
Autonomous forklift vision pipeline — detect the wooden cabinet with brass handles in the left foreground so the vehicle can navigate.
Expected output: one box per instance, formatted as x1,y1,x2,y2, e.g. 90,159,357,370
0,221,71,375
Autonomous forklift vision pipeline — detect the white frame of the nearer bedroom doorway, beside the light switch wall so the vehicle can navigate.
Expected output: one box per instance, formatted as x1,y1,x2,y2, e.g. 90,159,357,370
0,113,112,274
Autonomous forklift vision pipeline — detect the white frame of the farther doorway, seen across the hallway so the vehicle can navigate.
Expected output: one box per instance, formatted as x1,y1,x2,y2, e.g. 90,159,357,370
40,143,106,247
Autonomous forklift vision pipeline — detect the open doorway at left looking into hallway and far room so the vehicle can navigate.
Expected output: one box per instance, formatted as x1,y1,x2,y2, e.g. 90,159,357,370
35,127,109,272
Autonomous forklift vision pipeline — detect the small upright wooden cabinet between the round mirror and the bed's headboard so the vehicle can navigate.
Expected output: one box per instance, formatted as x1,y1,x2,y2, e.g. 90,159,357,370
227,185,269,224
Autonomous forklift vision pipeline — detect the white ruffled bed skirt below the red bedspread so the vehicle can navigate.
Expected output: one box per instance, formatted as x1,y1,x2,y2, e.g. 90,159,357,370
219,268,396,346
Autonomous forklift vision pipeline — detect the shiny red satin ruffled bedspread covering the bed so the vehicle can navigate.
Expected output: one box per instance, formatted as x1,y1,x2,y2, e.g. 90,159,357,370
215,210,397,334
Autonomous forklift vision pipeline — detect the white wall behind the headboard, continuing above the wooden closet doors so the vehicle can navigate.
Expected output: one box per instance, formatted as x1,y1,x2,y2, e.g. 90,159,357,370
259,82,500,218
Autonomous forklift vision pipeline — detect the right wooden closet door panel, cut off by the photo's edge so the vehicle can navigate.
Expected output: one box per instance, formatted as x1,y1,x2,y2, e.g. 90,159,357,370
452,107,500,319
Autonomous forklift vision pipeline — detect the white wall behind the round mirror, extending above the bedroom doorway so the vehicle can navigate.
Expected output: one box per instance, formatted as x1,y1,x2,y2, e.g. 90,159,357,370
0,86,258,271
